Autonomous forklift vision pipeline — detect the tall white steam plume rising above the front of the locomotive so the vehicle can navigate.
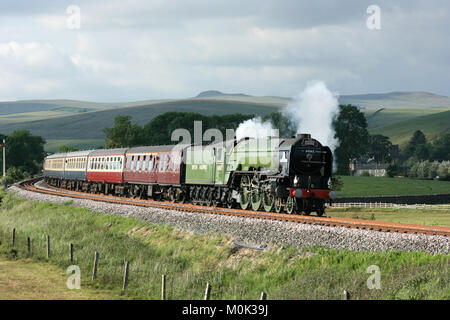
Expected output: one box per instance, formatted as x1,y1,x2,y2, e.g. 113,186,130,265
285,81,339,152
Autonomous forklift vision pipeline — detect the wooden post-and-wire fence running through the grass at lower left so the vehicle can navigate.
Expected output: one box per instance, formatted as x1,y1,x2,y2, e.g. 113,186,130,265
0,227,276,300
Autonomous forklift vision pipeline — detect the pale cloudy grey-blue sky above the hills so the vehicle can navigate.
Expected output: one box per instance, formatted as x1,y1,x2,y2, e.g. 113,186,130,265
0,0,450,102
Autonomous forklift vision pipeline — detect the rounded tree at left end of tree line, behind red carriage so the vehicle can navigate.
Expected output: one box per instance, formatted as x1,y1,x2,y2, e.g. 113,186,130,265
103,115,144,149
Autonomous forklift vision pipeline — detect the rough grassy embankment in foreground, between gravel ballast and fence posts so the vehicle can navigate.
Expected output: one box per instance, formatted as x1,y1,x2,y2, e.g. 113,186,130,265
0,189,450,299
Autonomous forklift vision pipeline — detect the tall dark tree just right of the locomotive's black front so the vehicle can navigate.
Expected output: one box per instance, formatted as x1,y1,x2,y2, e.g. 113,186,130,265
333,105,369,175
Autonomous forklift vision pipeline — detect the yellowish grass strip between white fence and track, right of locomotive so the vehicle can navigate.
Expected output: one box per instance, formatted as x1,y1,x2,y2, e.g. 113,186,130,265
326,205,450,227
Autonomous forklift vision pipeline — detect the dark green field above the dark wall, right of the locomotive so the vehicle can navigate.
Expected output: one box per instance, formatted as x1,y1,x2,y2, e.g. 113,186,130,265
337,176,450,197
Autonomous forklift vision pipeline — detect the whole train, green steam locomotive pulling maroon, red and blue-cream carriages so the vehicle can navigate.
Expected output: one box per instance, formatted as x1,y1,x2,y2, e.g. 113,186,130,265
43,134,335,216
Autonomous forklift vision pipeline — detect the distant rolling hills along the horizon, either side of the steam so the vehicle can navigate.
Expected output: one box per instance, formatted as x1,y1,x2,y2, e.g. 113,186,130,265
0,91,450,152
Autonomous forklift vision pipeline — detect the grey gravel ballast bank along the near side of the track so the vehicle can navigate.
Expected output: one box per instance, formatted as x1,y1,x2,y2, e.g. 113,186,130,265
8,186,450,254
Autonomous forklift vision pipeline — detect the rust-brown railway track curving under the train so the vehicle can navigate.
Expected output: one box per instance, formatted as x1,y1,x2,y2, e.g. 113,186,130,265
18,178,450,237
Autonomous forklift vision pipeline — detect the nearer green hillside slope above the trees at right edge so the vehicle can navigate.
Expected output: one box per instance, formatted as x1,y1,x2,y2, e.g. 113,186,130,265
370,110,450,144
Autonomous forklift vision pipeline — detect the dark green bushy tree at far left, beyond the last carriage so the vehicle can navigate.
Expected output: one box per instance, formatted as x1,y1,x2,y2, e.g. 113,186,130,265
6,130,45,173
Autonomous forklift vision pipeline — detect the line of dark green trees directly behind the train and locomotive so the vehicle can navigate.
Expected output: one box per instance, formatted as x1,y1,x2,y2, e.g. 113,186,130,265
103,105,372,174
